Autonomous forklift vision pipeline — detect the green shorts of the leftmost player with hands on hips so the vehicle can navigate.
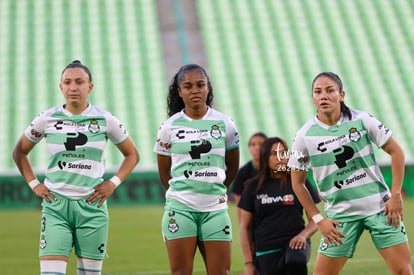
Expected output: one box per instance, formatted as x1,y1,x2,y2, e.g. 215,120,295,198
39,193,109,260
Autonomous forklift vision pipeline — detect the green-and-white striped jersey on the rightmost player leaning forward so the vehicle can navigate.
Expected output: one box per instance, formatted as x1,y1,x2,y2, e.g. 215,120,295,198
288,110,392,221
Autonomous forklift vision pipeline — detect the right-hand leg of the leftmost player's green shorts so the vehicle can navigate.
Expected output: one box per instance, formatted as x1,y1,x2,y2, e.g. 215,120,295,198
72,200,109,260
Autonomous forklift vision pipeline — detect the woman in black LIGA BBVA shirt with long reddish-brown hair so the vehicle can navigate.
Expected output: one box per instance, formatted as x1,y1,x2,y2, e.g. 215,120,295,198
238,137,320,275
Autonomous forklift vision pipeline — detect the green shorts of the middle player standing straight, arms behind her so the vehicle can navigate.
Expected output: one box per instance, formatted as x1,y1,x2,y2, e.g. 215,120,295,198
162,209,232,241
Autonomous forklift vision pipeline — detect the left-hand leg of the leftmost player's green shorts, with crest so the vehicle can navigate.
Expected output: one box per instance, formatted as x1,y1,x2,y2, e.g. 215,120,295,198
39,199,73,257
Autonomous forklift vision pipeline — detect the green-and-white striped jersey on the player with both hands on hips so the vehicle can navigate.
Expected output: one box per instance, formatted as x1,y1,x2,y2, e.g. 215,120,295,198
25,104,128,199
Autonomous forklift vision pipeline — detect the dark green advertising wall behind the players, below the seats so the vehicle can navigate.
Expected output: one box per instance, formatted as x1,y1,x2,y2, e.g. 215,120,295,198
0,166,414,210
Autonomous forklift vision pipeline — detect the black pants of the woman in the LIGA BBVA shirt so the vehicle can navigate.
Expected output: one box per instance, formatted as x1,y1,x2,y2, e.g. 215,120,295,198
255,240,311,275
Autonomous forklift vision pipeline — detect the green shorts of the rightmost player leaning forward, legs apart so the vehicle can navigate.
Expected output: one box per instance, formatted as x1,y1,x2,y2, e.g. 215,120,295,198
318,212,408,258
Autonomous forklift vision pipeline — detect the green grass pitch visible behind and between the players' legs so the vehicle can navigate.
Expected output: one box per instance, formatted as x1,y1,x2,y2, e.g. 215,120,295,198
0,199,414,275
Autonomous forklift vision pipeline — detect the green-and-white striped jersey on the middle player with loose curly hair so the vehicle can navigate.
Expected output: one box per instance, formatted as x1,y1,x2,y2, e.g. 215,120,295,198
154,108,239,212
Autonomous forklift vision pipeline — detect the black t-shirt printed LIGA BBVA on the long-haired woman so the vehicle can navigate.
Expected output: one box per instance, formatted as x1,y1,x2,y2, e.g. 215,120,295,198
237,177,320,252
